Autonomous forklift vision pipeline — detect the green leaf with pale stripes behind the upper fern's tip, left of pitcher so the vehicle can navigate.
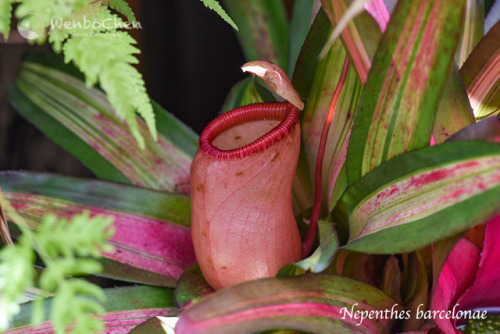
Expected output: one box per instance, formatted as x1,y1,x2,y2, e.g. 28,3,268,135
9,58,197,193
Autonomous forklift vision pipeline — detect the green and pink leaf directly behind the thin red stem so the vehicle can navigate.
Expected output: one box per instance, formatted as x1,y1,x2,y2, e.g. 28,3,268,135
302,36,362,211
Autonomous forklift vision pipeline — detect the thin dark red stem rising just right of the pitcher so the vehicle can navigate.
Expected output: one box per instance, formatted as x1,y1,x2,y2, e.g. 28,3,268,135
302,56,349,257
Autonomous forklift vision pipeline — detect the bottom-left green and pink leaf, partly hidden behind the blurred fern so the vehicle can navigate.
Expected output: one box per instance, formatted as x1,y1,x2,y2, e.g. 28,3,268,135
4,286,177,334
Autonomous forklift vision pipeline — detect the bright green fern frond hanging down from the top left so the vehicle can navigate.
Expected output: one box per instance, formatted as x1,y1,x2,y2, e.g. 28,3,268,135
12,0,157,148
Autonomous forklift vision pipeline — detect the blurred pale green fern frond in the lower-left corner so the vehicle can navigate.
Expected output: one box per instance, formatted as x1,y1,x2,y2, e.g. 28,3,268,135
0,195,114,334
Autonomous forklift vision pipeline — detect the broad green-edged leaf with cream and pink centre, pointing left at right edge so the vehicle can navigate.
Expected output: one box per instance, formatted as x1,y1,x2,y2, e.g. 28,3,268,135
334,142,500,254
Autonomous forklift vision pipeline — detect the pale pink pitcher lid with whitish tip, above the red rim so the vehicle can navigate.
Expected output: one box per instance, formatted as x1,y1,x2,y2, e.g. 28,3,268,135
241,60,304,110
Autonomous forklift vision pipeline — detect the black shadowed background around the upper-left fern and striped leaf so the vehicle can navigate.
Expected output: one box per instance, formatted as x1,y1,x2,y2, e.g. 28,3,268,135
0,0,250,177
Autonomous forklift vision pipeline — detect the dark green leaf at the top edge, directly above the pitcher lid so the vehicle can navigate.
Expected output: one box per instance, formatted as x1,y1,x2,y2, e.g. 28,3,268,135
224,0,289,69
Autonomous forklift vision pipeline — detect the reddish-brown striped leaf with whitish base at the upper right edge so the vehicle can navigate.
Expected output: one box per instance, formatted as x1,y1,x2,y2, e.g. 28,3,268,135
460,22,500,119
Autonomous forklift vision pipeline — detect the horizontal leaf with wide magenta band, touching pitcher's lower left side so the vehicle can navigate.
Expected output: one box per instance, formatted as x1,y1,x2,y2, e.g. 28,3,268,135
0,172,196,286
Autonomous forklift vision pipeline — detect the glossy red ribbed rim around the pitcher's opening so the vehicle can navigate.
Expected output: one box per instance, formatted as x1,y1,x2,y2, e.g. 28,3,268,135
199,102,299,160
